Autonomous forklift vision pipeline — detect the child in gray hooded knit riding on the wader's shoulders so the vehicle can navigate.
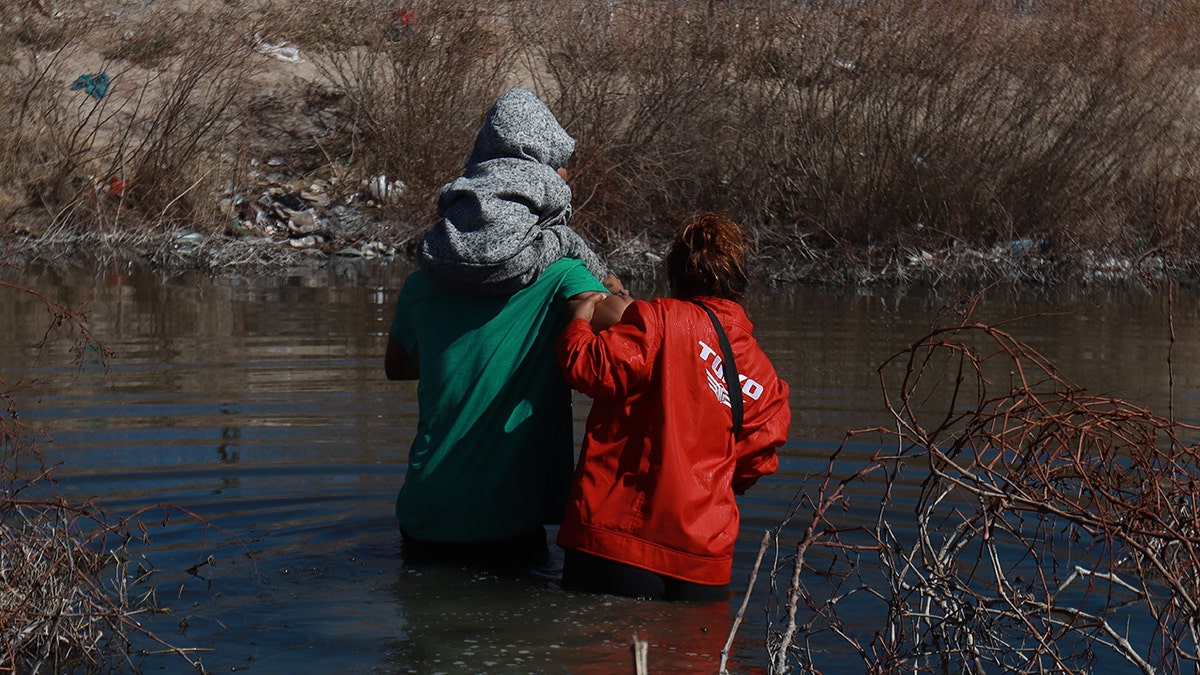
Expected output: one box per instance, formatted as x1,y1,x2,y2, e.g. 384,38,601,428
416,88,607,295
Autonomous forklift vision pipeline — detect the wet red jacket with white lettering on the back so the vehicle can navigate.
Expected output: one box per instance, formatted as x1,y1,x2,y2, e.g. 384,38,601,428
556,298,792,585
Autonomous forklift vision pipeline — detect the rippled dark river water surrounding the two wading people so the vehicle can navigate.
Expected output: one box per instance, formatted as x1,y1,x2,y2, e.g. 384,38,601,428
0,263,1200,673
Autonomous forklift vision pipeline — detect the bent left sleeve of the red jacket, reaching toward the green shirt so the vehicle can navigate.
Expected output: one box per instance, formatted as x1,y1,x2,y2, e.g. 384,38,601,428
554,300,661,399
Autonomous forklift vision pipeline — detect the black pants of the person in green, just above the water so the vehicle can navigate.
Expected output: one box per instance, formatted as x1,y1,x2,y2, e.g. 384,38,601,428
400,526,550,569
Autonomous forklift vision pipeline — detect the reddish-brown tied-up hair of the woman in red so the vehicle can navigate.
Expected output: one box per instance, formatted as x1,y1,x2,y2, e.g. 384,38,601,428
667,214,748,300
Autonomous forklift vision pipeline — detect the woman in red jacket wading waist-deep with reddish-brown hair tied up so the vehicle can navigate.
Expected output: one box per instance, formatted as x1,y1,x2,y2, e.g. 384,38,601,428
556,215,791,601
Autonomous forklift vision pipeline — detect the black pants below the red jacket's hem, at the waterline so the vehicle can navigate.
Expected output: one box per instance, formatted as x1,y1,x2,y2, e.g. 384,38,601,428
563,549,730,602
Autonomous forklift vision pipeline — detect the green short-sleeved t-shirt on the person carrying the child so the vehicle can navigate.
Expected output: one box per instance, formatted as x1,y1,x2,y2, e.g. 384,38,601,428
391,258,604,542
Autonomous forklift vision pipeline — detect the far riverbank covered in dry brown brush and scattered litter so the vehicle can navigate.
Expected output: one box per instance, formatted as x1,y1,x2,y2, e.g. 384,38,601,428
0,0,1200,285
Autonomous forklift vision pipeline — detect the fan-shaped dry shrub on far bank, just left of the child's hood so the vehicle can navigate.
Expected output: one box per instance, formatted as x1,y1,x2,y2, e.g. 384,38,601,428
317,0,514,221
